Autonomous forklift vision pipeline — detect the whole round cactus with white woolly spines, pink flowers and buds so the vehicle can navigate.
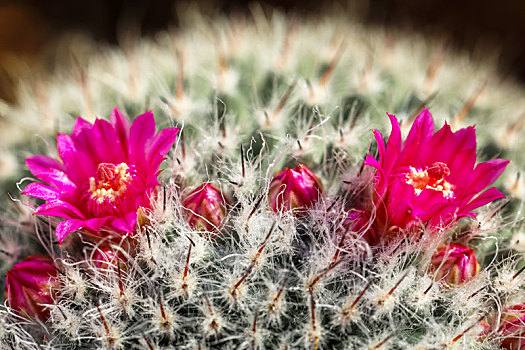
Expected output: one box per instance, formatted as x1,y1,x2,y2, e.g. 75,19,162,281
0,6,525,349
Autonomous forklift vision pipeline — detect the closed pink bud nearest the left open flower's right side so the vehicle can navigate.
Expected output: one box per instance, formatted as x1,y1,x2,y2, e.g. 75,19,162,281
182,183,227,232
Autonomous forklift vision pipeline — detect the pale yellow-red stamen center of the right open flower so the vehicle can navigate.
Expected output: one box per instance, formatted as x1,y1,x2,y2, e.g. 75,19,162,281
405,162,454,199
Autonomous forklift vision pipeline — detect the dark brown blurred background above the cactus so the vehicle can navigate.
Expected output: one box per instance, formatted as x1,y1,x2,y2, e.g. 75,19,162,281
0,0,525,102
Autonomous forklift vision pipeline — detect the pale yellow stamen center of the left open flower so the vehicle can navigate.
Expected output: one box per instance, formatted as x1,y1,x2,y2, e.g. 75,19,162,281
89,163,133,204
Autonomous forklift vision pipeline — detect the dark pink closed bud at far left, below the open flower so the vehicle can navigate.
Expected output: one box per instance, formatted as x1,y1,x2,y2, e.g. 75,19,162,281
5,255,58,321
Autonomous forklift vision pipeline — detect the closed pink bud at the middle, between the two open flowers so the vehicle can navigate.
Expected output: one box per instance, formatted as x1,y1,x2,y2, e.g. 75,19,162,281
268,164,323,213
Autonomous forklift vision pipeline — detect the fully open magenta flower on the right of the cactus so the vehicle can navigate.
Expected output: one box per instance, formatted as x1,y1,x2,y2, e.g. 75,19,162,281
365,109,509,244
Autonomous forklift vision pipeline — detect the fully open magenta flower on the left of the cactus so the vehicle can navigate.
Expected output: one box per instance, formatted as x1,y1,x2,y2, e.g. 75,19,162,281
23,108,179,242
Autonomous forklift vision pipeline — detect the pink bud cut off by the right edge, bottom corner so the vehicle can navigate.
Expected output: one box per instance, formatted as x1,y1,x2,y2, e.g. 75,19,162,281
498,304,525,350
